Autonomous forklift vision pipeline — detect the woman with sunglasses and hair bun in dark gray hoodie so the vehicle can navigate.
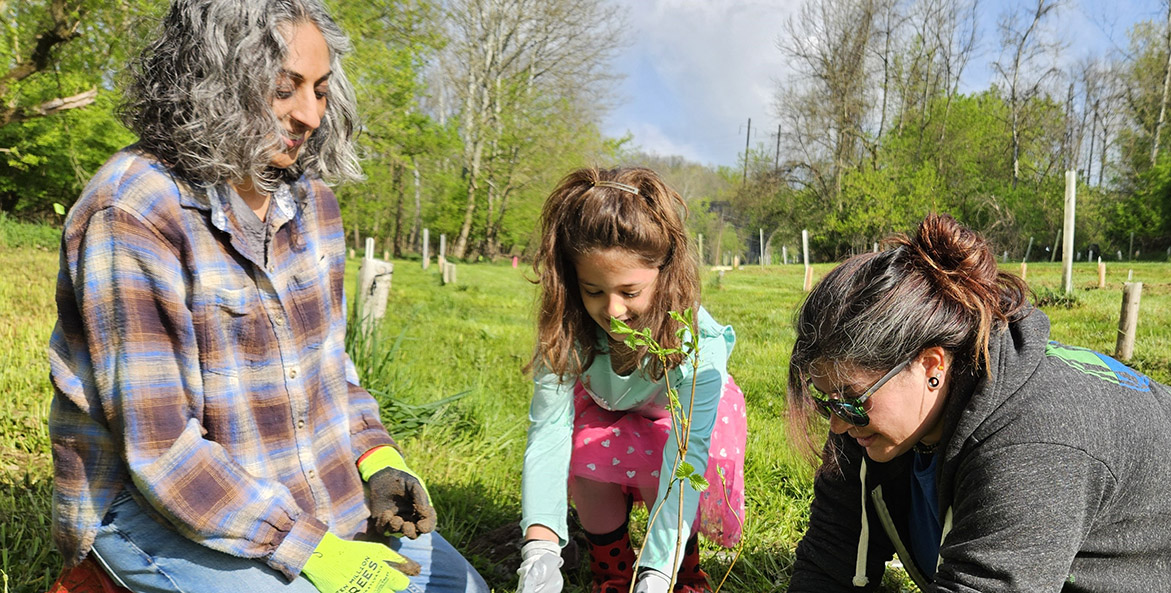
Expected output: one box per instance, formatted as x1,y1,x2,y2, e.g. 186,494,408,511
788,214,1171,592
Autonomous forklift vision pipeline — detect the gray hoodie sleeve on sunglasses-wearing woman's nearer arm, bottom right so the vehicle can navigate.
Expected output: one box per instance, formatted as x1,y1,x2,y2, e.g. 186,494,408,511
929,443,1115,593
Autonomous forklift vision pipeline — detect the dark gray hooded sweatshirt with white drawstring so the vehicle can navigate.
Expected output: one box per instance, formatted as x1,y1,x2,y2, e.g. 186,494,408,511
789,309,1171,593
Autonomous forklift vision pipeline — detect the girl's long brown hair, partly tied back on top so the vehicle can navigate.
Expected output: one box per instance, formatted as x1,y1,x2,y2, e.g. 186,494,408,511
525,168,699,379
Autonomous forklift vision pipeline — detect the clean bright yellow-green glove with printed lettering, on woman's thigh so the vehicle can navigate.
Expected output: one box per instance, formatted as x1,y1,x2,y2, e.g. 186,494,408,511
301,532,420,593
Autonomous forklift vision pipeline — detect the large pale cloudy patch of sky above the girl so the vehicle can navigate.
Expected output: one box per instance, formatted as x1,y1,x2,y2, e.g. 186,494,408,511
607,0,797,165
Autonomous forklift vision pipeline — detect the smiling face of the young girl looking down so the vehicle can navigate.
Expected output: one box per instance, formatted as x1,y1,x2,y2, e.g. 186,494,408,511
574,247,659,341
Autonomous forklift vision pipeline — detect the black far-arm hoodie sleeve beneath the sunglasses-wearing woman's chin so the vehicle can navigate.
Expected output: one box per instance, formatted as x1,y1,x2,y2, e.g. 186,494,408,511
788,435,895,593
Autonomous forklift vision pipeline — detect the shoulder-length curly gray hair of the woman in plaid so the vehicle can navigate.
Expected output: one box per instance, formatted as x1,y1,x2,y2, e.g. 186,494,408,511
119,0,362,192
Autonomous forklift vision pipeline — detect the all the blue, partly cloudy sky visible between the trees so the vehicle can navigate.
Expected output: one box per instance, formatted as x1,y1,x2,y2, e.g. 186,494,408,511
603,0,1166,165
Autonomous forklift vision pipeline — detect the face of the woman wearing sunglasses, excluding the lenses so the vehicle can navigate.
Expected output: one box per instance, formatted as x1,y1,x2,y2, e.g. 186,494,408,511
812,348,951,462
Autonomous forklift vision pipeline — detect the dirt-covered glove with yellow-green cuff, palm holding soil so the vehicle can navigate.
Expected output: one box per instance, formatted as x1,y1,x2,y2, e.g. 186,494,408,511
358,445,436,539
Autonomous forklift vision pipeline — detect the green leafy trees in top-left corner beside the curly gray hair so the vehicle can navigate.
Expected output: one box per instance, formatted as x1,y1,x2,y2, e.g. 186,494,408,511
0,0,162,218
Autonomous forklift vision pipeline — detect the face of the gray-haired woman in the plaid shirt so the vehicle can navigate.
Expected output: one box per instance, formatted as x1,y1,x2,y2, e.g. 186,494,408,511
271,23,333,169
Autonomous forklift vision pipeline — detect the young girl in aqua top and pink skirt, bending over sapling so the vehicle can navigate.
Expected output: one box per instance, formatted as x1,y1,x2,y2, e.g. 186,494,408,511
518,169,746,593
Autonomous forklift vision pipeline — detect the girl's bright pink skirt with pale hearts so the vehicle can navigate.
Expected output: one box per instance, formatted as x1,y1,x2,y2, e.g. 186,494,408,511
569,377,748,547
